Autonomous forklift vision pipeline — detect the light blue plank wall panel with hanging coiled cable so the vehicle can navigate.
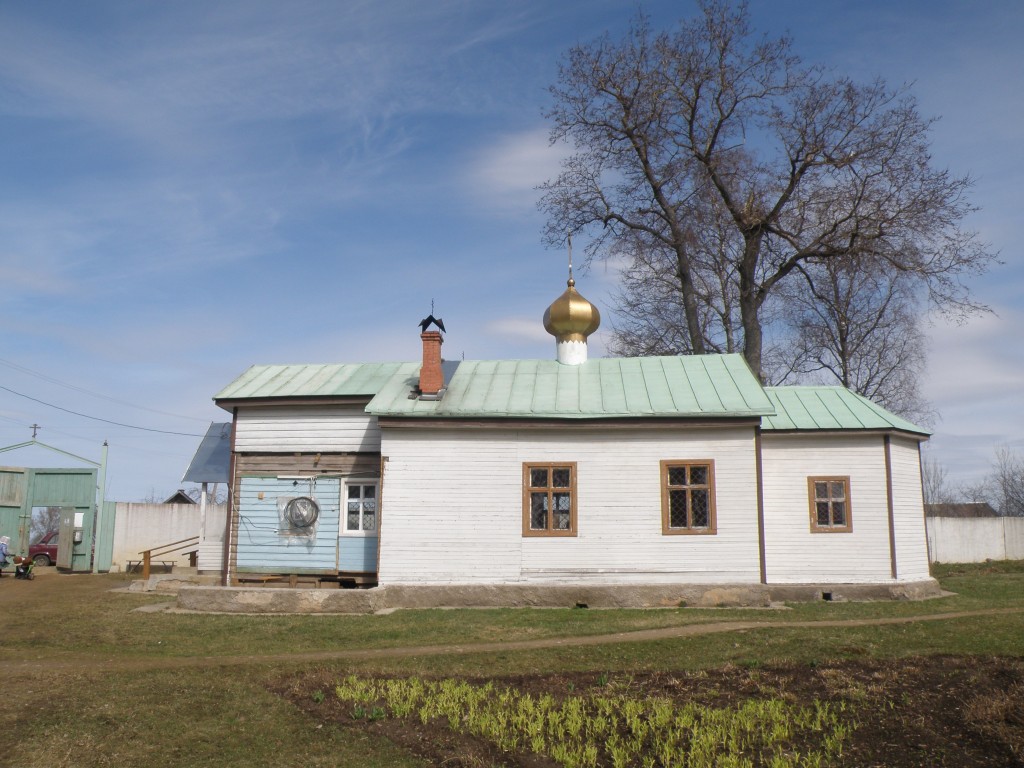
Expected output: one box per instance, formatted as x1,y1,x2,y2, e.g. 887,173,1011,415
236,476,341,573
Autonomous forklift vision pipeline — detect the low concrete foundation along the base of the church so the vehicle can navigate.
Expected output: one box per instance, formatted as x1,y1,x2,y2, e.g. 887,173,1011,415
169,579,941,613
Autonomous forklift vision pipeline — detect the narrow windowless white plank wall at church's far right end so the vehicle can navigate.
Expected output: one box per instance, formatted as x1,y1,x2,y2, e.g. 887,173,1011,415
890,437,930,582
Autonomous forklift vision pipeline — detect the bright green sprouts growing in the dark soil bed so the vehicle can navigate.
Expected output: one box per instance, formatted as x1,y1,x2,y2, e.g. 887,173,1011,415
336,676,855,768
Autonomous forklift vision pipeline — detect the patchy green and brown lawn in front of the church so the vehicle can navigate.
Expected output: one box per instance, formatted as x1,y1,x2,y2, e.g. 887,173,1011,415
6,562,1024,767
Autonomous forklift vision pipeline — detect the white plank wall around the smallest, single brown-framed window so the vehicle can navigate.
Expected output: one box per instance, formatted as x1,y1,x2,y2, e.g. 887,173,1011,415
762,433,892,584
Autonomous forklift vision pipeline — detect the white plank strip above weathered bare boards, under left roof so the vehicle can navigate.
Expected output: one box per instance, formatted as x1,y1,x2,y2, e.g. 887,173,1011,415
234,406,381,453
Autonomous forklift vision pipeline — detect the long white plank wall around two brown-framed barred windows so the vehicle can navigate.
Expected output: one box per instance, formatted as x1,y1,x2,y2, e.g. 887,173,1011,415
380,427,759,583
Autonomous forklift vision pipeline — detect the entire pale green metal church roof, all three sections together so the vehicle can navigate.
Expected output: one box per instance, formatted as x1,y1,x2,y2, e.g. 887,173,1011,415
214,354,929,435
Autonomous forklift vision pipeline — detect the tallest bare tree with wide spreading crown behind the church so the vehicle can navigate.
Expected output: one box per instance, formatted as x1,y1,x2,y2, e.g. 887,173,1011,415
540,0,993,379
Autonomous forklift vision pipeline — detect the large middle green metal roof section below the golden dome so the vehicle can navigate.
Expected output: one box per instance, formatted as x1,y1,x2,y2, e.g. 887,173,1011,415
367,354,774,419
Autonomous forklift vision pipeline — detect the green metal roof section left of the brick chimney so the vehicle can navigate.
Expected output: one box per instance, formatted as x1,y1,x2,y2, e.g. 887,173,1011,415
214,362,420,400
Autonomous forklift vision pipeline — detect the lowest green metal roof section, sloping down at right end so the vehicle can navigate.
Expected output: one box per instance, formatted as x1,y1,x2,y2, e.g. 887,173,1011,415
761,387,931,435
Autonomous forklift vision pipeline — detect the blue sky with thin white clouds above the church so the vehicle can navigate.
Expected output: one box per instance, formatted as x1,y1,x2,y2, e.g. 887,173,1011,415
0,0,1024,501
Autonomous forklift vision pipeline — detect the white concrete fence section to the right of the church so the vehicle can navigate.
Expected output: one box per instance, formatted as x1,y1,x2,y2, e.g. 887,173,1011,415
926,517,1024,562
